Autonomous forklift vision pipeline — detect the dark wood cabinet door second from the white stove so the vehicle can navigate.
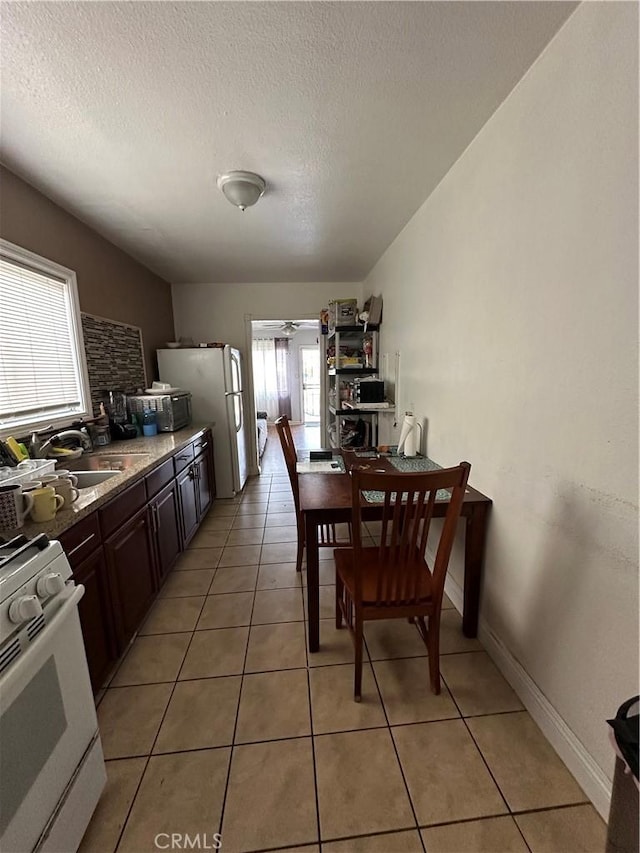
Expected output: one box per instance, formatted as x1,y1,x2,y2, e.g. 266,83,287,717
104,508,157,652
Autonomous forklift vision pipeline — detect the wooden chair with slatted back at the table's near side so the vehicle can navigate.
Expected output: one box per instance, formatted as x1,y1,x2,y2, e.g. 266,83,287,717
334,462,471,702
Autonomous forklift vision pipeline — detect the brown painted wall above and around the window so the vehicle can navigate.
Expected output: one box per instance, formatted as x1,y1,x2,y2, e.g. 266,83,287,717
0,167,174,380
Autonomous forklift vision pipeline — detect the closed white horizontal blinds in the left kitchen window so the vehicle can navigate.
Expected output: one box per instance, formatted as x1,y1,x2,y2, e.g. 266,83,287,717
0,251,86,432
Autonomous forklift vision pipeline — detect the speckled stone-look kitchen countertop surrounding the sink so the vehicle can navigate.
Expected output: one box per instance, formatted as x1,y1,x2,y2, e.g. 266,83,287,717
6,423,213,539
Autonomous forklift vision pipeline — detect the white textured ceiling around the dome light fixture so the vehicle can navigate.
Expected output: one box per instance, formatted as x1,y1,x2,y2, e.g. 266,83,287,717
0,2,577,282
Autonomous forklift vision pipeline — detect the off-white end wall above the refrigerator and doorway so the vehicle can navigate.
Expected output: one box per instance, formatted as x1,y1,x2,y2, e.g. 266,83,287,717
172,281,362,352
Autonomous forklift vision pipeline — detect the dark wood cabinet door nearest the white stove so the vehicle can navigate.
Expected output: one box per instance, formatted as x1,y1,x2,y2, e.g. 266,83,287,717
73,548,117,693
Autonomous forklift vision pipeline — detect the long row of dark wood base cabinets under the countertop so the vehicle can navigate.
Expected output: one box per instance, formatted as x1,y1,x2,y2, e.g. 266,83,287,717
59,430,215,692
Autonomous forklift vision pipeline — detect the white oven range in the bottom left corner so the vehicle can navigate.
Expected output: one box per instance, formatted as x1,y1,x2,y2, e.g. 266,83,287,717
0,535,106,853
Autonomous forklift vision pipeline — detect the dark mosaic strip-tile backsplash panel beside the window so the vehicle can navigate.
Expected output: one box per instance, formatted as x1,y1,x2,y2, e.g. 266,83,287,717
81,313,147,414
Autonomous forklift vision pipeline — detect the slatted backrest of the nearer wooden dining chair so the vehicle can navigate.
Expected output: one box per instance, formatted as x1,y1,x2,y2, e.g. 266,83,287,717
351,462,471,607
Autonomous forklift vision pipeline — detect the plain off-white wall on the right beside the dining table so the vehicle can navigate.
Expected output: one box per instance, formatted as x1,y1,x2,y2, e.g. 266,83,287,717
364,3,638,810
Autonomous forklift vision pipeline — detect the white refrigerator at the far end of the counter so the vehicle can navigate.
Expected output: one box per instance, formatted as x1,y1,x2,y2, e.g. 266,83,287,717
157,345,247,498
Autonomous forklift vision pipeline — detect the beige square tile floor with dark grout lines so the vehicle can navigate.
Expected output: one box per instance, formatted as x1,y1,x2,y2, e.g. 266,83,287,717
81,426,606,853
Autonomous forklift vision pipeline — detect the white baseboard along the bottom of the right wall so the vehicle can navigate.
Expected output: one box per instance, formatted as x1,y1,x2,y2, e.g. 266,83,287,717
445,575,612,822
